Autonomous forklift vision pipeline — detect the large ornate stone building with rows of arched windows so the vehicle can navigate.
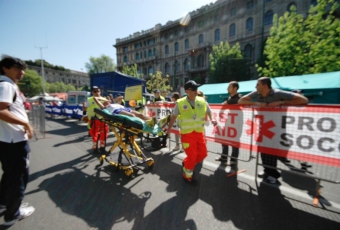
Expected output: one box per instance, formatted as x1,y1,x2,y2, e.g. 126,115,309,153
114,0,316,91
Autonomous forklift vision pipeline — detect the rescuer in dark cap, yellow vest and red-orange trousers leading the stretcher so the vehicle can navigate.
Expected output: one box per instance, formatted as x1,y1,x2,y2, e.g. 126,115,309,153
168,80,217,182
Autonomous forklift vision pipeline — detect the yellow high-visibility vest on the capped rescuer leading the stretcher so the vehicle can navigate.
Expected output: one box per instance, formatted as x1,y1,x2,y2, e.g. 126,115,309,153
177,97,207,134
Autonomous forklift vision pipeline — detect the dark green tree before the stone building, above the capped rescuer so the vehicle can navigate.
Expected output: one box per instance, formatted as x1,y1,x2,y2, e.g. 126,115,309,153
209,42,250,83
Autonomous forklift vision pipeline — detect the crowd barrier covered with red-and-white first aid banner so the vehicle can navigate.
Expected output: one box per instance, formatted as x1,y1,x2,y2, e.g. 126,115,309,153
146,104,340,204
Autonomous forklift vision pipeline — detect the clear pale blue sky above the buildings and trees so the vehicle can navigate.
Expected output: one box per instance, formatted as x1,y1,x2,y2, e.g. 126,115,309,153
0,0,216,72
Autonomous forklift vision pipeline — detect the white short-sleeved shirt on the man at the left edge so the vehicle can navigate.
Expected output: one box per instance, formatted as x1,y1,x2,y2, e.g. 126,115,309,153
0,75,28,143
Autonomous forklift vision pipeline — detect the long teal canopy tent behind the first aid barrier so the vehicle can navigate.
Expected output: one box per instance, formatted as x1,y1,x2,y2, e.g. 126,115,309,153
199,71,340,104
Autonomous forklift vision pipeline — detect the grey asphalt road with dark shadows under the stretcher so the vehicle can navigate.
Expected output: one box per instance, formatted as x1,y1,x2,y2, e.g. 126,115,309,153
0,118,340,230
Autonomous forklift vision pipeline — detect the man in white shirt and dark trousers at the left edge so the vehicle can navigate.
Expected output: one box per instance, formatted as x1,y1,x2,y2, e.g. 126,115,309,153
0,56,35,226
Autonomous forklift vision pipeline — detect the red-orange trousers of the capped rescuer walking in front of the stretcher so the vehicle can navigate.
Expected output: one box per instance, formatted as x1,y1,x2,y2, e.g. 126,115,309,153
181,131,208,170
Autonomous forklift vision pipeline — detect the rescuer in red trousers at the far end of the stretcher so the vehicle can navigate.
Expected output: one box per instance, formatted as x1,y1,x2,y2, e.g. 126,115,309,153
87,86,109,152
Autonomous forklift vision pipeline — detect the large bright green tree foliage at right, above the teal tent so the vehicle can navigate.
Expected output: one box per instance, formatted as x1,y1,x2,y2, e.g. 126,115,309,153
257,0,340,77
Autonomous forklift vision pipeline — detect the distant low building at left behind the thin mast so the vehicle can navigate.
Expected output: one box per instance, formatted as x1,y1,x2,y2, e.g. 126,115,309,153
28,65,90,90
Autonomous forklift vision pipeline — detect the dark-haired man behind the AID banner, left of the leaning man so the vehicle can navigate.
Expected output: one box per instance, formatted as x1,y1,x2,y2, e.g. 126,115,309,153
215,81,242,166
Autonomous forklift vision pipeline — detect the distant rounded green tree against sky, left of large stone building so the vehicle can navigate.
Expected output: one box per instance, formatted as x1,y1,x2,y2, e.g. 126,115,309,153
85,54,116,74
